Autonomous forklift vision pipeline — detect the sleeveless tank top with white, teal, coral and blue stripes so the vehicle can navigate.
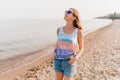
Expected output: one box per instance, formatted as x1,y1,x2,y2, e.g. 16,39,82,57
55,27,79,59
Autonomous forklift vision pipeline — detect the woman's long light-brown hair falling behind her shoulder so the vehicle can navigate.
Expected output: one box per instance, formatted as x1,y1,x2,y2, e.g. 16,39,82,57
70,8,83,30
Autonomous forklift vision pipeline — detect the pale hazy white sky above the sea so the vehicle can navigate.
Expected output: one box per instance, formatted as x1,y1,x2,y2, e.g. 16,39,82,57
0,0,120,19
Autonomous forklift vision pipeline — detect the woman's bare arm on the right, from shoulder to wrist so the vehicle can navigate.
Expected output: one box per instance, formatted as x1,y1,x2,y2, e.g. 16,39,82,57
76,29,84,59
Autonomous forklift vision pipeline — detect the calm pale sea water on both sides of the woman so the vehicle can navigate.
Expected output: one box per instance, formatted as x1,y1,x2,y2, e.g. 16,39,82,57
0,19,111,60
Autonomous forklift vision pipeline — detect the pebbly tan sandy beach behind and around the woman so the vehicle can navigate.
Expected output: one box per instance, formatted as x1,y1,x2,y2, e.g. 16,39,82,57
0,20,120,80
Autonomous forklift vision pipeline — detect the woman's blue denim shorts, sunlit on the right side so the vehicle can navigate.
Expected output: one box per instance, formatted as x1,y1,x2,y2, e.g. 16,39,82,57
54,58,77,77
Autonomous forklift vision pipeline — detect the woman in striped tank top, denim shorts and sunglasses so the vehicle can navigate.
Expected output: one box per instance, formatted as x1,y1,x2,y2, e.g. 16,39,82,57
54,8,84,80
